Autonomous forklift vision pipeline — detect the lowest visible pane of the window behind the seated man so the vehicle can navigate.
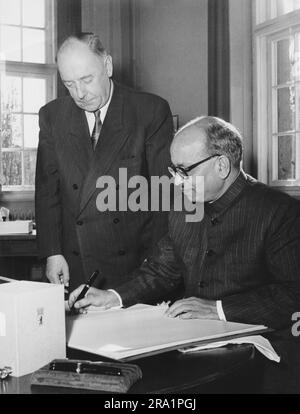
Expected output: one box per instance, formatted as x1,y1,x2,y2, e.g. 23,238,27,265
278,135,296,180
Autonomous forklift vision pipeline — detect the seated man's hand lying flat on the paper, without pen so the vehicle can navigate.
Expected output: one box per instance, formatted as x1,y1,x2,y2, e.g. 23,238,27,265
166,297,219,319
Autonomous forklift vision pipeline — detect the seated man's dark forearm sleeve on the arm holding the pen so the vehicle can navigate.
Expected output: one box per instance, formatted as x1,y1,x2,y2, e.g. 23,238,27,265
115,235,183,307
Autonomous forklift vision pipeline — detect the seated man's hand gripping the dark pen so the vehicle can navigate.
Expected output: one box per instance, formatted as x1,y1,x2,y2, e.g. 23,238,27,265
69,285,120,313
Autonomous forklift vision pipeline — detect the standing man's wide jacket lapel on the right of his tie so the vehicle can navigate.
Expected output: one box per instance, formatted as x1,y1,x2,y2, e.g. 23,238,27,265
80,84,129,212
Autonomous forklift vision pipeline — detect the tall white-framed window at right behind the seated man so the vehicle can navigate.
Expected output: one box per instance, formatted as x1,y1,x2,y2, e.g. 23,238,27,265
254,0,300,196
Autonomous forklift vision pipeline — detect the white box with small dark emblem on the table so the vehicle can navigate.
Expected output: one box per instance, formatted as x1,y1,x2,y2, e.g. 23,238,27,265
0,281,66,377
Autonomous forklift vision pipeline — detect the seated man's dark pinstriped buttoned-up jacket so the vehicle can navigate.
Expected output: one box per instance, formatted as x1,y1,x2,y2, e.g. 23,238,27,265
117,172,300,329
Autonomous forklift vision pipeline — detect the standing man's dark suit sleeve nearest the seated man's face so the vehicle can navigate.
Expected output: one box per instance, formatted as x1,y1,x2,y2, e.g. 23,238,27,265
146,99,174,246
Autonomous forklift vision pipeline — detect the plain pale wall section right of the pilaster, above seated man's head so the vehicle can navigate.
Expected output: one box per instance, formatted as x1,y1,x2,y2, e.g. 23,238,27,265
135,0,207,124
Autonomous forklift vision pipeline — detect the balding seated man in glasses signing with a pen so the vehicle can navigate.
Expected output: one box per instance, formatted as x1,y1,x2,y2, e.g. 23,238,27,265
70,117,300,329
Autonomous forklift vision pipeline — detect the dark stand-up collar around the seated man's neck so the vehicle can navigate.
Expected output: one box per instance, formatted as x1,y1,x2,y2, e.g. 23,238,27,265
205,170,248,215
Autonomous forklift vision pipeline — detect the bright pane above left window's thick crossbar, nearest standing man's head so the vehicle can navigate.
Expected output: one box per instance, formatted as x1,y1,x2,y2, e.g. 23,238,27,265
23,29,45,63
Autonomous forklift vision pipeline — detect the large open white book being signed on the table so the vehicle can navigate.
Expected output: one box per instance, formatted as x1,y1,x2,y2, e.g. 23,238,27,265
67,304,267,361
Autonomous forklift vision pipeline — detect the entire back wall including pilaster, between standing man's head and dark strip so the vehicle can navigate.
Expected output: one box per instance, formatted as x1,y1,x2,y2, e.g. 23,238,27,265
82,0,207,128
